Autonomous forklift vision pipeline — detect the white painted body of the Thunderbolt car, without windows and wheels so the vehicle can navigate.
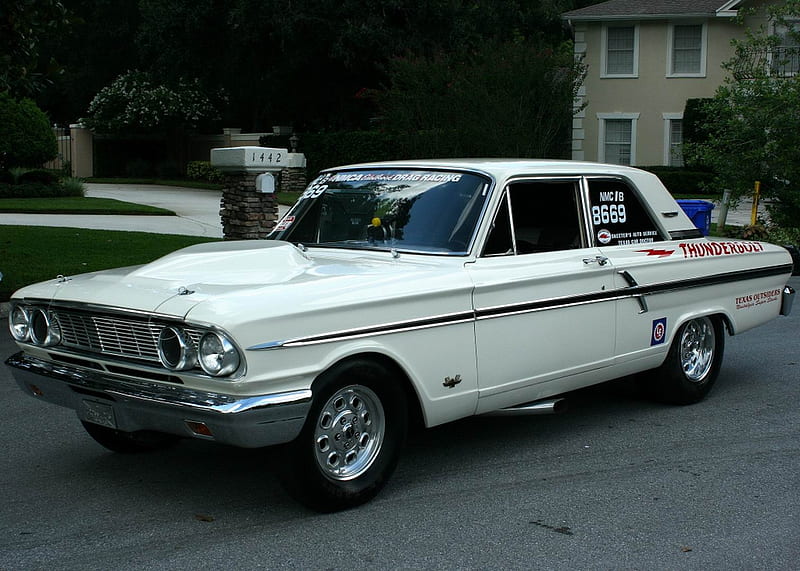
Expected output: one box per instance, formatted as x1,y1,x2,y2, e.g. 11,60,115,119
6,160,791,445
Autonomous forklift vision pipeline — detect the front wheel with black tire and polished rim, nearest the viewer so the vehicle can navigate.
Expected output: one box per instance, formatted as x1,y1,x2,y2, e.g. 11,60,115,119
279,359,408,513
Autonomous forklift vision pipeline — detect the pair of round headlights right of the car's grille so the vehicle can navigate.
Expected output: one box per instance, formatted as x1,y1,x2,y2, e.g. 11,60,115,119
158,326,240,377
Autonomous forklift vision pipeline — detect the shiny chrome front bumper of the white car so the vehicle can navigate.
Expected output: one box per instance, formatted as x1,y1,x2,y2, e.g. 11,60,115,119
6,352,311,448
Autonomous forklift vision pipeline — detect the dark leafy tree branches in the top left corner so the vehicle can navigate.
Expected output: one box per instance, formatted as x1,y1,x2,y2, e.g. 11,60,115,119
0,0,67,97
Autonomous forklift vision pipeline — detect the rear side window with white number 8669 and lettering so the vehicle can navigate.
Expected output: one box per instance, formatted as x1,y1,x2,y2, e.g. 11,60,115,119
589,179,664,246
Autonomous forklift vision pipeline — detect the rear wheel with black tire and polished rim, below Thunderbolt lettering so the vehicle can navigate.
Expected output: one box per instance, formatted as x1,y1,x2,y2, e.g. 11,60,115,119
642,317,725,405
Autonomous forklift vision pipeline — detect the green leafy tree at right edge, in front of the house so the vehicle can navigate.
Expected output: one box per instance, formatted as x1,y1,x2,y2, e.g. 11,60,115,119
685,0,800,228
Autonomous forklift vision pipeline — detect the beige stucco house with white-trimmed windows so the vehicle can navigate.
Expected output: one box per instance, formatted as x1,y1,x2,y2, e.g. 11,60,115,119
562,0,788,166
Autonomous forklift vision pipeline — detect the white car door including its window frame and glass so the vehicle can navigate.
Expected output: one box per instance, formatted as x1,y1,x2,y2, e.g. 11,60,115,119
468,178,616,413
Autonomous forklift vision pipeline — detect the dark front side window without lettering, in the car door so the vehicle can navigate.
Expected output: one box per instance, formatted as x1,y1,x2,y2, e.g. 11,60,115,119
484,181,583,256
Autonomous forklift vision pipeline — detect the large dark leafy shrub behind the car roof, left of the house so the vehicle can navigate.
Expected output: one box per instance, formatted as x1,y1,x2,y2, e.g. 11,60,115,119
378,38,584,158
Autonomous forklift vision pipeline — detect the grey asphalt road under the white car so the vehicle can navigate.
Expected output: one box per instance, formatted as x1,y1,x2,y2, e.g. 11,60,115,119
0,278,800,571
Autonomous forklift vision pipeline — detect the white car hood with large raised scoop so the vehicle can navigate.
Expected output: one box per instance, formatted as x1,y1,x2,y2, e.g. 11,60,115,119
29,240,456,317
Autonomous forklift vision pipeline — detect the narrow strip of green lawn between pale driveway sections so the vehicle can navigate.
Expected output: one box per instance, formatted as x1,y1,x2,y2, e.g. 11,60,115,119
0,196,175,216
